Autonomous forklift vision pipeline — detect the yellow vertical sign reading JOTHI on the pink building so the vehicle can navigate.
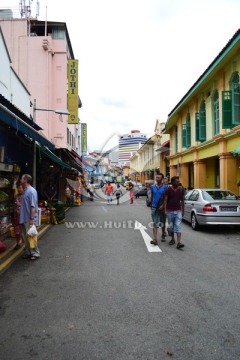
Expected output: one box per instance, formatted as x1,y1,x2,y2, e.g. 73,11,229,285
68,60,78,124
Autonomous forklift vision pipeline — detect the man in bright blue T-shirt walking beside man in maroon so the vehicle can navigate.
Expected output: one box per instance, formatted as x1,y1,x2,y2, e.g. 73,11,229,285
150,173,167,245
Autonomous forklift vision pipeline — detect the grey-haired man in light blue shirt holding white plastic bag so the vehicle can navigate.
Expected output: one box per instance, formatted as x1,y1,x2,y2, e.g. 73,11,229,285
19,174,40,260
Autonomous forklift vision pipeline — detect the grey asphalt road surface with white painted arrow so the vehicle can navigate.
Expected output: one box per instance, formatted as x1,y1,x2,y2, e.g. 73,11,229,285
0,194,240,360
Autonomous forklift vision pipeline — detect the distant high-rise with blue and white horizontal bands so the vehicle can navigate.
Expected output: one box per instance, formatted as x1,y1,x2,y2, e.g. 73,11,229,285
118,130,147,165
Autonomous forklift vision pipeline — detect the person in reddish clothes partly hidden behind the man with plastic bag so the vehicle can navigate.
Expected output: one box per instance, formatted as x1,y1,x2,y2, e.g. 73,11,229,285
13,184,24,250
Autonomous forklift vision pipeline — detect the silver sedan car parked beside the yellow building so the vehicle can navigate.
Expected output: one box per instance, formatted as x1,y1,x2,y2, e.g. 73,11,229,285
183,189,240,230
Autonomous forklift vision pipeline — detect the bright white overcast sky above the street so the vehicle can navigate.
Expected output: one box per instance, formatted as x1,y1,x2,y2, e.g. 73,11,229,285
0,0,240,151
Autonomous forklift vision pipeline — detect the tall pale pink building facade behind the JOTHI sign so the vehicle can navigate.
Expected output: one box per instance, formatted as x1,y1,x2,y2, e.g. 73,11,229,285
0,19,81,153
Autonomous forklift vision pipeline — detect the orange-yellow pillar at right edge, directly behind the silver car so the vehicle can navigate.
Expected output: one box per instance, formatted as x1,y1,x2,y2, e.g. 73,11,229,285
219,153,238,194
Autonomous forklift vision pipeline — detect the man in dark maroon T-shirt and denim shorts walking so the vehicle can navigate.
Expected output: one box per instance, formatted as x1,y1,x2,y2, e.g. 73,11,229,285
164,176,184,249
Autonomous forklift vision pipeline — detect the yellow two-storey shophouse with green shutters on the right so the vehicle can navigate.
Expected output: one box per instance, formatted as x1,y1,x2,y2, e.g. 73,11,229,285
165,30,240,193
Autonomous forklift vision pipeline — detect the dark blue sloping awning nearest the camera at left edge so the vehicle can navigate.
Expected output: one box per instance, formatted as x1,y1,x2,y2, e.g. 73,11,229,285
0,104,55,150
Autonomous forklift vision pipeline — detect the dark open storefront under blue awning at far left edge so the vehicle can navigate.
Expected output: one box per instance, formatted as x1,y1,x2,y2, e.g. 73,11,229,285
0,95,54,238
